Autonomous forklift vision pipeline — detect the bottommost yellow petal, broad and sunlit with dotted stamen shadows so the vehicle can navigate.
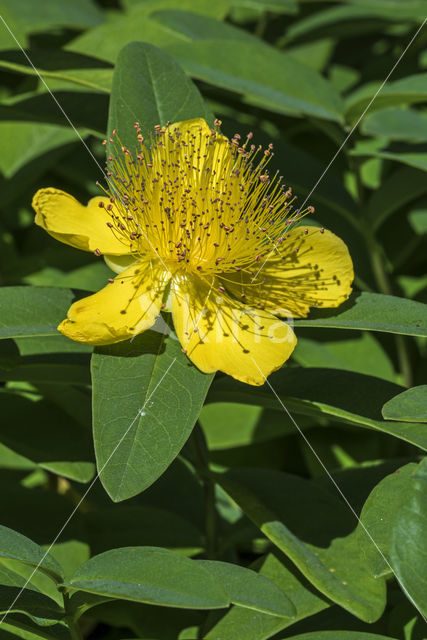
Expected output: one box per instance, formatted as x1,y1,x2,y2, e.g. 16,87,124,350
171,277,296,385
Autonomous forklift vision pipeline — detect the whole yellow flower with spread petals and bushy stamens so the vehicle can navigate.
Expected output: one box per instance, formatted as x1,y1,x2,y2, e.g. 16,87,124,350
33,119,353,385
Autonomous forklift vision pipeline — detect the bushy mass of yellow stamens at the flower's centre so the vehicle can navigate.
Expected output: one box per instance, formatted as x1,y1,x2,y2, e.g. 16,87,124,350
100,120,313,282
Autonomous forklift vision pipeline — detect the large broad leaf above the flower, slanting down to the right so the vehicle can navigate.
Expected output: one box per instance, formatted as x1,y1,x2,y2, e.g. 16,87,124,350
166,38,342,122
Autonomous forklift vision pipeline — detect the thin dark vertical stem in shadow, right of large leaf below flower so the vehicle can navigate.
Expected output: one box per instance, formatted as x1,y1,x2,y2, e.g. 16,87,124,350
190,423,217,560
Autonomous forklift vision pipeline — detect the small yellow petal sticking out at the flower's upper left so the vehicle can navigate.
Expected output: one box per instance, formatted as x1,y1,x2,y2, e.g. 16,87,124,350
32,188,130,255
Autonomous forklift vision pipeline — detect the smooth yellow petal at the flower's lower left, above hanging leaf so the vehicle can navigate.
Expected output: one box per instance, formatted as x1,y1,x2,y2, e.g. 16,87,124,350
58,261,170,345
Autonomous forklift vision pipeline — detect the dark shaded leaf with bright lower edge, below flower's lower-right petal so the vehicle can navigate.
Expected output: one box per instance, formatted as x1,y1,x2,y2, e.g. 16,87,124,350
208,367,427,450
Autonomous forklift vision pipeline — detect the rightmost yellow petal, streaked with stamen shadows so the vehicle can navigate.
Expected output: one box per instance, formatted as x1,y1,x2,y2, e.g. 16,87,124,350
225,226,354,318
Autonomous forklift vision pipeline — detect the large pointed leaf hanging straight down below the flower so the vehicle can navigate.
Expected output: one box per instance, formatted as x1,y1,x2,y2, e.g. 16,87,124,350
92,331,213,501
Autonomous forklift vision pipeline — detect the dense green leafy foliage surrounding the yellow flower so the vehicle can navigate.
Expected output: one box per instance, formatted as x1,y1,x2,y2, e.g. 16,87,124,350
0,0,427,640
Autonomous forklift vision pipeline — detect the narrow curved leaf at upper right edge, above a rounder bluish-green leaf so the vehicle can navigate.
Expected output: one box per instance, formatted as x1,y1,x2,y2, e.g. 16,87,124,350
345,73,427,122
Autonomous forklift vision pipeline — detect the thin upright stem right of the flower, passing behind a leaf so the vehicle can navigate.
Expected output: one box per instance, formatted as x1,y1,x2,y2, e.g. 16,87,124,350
352,156,413,387
